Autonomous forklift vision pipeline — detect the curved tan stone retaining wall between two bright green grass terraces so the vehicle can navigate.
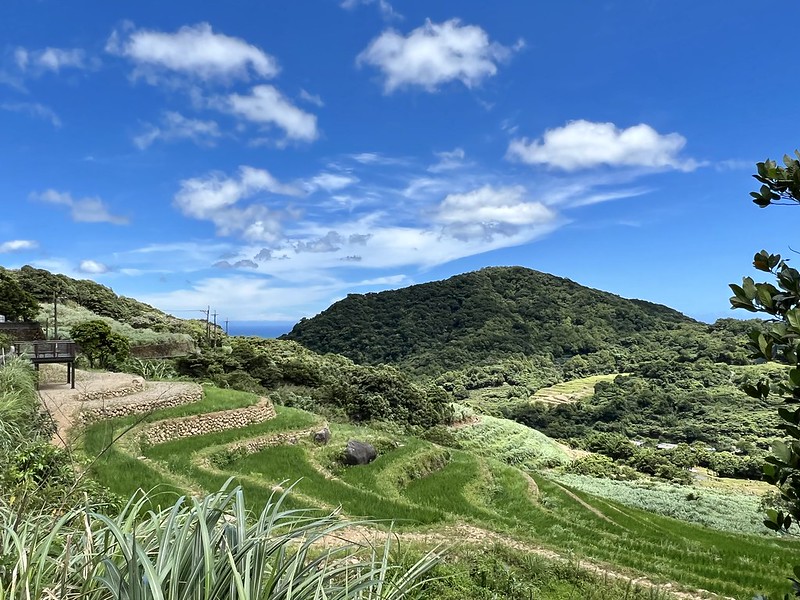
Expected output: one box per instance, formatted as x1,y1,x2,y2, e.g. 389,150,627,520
141,398,275,444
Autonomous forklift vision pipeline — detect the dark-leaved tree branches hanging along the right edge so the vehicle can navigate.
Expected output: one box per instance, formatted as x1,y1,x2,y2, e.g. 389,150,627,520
730,151,800,597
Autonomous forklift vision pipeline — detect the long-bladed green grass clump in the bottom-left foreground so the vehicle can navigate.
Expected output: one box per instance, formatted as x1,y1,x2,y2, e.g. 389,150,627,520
0,487,440,600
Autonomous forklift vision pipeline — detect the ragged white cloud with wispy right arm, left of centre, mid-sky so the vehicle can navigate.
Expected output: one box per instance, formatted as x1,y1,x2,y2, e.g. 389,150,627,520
174,166,302,242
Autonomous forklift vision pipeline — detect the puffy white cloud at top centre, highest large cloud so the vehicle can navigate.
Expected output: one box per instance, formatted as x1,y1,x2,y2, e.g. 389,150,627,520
356,19,522,94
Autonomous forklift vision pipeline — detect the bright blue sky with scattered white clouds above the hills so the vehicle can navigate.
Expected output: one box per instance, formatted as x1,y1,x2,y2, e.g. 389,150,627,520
0,0,800,328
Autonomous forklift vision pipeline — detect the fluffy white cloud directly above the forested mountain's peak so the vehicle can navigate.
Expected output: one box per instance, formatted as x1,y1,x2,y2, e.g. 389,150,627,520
436,185,556,238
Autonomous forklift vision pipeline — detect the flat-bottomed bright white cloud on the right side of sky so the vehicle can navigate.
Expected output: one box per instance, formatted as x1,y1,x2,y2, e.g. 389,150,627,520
507,120,700,171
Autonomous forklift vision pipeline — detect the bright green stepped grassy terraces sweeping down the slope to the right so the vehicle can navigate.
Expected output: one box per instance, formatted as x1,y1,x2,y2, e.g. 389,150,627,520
79,389,800,600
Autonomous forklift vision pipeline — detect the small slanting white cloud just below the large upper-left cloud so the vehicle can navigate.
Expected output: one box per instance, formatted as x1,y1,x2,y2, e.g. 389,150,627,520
220,85,318,142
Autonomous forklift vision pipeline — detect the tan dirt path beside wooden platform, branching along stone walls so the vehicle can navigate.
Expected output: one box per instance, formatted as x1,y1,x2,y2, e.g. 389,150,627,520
34,365,194,447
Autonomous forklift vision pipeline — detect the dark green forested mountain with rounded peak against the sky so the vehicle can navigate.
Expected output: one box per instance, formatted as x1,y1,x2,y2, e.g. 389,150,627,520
284,267,744,374
